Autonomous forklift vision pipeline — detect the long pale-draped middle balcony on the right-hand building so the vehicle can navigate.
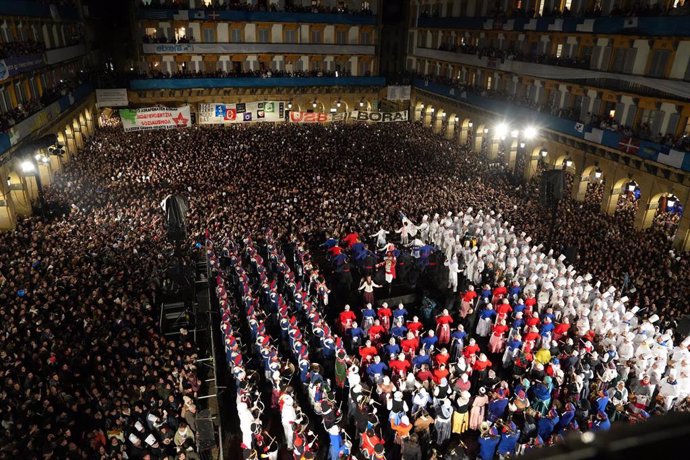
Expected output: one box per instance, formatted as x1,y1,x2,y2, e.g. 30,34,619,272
415,48,690,100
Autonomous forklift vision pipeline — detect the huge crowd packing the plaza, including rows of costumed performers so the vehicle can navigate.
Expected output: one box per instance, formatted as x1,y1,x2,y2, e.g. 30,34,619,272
0,119,690,460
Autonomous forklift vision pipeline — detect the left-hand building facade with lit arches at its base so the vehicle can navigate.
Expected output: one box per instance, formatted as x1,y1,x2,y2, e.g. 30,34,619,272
0,0,96,229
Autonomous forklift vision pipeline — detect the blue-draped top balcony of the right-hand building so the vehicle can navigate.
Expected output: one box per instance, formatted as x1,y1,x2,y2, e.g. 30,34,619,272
417,16,690,37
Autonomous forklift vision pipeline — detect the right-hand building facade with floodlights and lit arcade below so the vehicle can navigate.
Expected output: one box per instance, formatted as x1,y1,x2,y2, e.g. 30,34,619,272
406,0,690,249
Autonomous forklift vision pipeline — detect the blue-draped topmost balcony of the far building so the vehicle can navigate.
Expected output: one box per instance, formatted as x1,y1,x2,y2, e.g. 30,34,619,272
137,8,376,26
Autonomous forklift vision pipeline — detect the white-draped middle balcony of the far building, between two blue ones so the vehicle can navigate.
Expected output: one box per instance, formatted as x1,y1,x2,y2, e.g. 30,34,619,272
143,43,376,56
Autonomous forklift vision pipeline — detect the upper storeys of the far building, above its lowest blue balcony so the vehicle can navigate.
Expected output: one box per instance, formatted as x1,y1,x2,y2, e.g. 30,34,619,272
134,0,379,76
